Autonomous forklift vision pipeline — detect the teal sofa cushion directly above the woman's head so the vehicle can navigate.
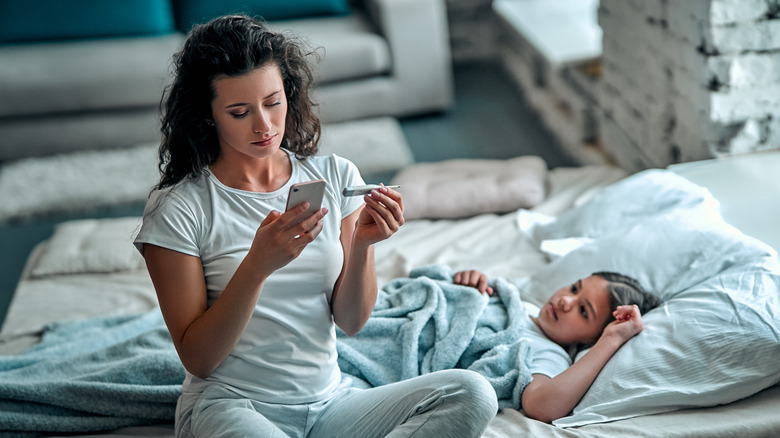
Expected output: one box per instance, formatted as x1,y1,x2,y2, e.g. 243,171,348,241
173,0,350,32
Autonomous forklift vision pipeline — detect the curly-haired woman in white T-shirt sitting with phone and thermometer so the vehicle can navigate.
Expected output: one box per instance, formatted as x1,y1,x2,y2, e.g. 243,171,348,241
136,15,497,437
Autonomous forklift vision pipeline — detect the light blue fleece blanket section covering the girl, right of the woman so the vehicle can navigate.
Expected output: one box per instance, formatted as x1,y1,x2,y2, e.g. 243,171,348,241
338,265,531,408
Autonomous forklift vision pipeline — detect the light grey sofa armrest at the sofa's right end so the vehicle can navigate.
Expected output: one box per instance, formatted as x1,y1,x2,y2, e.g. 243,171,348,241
363,0,454,112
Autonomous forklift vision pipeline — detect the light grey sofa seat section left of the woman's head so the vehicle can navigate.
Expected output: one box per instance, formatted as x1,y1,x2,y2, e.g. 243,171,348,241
0,33,184,117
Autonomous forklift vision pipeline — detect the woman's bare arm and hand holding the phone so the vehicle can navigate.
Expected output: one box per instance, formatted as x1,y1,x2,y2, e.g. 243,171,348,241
144,204,327,378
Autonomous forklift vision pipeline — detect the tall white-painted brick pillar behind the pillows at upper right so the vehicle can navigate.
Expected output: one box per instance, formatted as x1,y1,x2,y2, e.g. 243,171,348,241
597,0,780,170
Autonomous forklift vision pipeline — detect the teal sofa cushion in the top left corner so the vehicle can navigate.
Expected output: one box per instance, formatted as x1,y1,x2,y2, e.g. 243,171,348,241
0,0,176,43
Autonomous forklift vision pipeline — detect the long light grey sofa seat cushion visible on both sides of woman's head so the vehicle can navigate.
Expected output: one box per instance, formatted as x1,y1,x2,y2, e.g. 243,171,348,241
0,13,391,117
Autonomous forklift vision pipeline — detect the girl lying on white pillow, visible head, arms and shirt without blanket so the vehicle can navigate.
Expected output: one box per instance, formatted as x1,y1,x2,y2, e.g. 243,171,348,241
453,270,659,423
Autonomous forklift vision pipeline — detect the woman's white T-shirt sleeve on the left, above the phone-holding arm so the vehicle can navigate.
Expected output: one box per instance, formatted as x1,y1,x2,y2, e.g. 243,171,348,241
133,190,202,257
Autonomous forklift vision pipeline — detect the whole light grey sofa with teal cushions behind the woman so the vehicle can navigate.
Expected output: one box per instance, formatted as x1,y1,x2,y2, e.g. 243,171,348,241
0,0,453,163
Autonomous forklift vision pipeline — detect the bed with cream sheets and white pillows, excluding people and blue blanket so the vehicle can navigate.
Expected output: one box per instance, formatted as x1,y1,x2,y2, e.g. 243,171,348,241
0,156,780,437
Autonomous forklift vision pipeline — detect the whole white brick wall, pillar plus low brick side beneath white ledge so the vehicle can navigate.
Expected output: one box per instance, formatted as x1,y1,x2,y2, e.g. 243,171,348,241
494,0,780,171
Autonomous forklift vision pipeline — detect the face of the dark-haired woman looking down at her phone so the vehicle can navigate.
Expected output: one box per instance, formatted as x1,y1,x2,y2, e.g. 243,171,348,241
211,63,287,158
